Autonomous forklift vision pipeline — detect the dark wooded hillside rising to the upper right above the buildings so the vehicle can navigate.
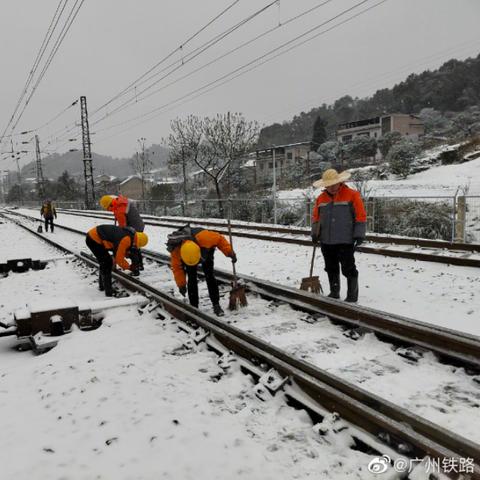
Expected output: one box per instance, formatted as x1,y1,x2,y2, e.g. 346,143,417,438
258,54,480,147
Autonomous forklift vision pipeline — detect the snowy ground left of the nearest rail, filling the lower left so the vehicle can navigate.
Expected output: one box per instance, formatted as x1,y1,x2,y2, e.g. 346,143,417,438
0,218,386,480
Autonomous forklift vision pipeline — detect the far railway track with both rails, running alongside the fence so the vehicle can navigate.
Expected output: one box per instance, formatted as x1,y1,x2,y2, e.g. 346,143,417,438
52,210,480,267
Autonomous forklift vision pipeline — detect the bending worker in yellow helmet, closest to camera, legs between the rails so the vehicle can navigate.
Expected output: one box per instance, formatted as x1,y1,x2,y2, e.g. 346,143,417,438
167,226,237,317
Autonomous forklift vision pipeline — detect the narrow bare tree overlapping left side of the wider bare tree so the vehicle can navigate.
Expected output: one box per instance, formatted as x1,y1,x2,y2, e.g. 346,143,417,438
164,115,203,214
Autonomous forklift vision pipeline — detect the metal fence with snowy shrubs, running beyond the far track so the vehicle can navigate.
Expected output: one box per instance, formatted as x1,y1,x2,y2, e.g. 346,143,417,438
11,195,480,243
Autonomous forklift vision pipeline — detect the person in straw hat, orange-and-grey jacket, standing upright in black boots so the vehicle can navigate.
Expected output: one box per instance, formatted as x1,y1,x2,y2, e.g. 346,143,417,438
312,168,367,302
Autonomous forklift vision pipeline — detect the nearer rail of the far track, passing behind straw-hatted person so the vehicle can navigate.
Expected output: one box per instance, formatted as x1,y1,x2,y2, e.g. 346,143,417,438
52,210,480,268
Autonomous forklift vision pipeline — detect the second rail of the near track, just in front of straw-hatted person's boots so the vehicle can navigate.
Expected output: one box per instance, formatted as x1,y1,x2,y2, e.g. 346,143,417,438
7,208,480,370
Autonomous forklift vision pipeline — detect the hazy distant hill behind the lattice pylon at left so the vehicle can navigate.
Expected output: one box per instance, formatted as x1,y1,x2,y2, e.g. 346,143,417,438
22,145,168,178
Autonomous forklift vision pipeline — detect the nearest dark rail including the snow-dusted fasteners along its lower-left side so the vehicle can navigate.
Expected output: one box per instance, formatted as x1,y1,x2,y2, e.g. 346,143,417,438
2,212,480,479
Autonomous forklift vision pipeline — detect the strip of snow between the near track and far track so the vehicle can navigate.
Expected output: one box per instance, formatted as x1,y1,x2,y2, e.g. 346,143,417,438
31,210,480,336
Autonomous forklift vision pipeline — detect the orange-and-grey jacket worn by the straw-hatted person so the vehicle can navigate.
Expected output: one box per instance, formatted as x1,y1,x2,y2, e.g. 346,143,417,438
312,183,367,245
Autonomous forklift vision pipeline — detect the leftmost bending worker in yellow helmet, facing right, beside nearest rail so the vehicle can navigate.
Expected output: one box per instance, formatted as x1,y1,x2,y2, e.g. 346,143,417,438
85,225,148,297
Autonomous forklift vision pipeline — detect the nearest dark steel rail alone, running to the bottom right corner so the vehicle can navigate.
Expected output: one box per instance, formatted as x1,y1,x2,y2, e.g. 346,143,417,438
1,217,480,480
